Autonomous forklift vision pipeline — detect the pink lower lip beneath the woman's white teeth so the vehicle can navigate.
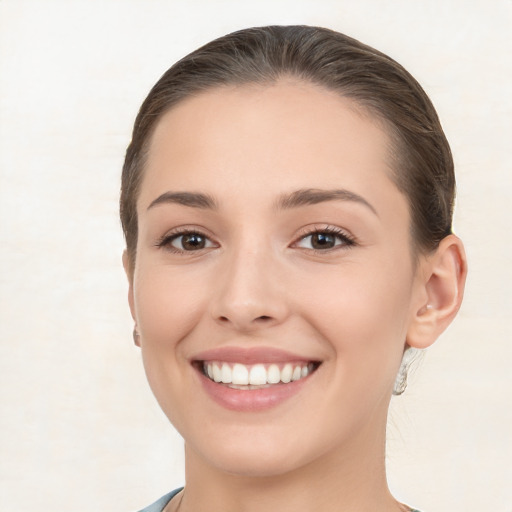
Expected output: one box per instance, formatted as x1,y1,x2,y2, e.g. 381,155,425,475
199,373,311,412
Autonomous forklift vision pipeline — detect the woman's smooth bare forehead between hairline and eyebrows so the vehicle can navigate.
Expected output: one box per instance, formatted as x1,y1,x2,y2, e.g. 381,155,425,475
140,79,402,212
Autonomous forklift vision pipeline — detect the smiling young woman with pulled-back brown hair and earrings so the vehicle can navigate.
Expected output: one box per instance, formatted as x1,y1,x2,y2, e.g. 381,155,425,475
121,26,466,512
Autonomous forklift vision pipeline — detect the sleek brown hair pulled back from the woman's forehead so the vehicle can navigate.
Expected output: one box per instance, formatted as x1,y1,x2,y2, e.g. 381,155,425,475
120,26,455,268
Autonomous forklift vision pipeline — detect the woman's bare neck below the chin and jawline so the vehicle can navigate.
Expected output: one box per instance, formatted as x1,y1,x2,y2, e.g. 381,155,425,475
179,412,409,512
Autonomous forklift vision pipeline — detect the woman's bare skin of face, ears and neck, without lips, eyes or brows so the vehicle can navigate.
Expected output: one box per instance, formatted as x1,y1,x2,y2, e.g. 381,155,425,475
124,80,465,512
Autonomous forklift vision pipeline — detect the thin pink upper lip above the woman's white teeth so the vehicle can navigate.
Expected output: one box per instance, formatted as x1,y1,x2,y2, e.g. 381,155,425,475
191,347,318,365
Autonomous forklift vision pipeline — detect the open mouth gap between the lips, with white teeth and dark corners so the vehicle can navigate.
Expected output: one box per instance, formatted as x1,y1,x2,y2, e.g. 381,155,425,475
197,361,320,390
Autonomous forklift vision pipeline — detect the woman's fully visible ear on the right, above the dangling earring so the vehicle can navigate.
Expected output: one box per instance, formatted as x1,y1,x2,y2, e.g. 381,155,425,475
407,235,467,348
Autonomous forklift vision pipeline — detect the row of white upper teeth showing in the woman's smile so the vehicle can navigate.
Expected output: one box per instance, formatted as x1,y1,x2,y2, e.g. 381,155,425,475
203,362,311,386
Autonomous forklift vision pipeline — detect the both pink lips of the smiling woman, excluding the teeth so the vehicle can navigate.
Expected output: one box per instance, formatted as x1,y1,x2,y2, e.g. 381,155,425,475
191,347,320,412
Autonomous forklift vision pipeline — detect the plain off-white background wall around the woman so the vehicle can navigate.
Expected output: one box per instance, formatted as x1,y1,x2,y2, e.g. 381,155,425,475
0,0,512,512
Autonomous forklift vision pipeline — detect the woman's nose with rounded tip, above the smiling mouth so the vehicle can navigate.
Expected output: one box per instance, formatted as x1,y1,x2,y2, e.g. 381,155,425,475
212,244,289,332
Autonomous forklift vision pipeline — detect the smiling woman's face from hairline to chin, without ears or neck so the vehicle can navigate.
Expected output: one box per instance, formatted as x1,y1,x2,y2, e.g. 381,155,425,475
130,81,428,475
